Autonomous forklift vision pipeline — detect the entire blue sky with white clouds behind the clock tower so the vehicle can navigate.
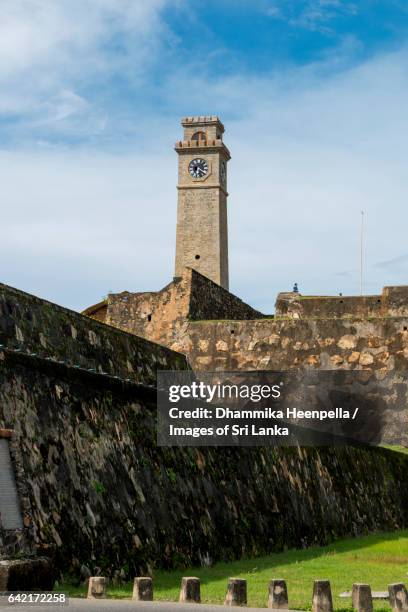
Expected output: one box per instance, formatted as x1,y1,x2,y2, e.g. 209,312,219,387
0,0,408,312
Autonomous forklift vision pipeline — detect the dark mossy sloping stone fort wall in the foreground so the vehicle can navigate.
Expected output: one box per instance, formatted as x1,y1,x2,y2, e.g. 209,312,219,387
0,285,408,574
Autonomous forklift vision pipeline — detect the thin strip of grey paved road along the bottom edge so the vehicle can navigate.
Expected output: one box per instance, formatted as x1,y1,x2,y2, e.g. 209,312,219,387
0,597,284,612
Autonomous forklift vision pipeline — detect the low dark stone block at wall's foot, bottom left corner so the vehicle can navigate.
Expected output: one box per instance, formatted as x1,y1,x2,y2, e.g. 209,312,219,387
0,557,55,592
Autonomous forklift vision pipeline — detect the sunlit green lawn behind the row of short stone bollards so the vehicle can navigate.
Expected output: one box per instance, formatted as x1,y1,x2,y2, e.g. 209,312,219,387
62,530,408,612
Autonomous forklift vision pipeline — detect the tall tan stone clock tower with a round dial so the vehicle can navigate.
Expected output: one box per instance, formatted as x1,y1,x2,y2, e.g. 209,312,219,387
175,116,230,289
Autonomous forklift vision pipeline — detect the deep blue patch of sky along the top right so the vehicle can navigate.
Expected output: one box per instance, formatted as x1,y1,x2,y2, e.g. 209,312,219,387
166,0,407,75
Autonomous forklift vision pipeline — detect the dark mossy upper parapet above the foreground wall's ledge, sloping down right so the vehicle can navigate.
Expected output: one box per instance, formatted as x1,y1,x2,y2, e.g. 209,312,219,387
0,283,186,384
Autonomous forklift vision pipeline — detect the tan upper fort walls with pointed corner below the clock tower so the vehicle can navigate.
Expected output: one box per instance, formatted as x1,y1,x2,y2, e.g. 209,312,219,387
86,269,408,380
